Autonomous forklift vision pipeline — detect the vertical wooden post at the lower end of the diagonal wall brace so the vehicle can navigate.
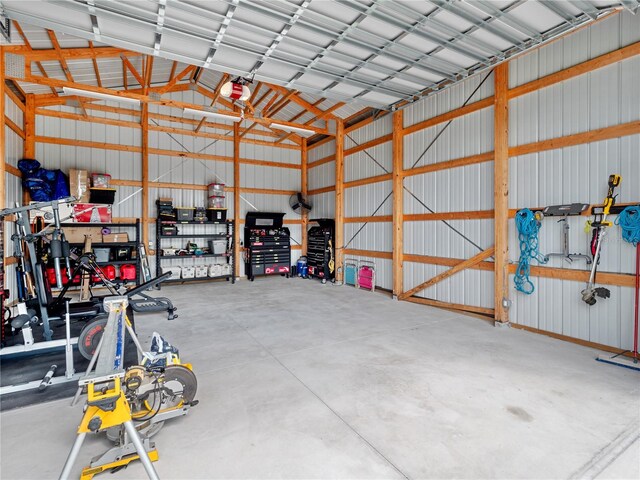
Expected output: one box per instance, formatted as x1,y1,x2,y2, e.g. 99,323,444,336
392,110,404,298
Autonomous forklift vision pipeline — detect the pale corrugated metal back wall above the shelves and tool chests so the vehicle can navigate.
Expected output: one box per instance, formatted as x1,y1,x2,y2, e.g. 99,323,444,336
30,91,301,274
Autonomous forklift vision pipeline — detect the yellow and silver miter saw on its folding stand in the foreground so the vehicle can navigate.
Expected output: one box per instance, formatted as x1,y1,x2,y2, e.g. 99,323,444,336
60,296,198,480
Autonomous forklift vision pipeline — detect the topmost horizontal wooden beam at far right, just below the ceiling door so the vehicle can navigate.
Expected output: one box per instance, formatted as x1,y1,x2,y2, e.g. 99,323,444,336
508,42,640,99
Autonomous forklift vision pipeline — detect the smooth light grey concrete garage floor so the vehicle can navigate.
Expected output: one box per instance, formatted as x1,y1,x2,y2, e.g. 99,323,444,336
0,278,640,480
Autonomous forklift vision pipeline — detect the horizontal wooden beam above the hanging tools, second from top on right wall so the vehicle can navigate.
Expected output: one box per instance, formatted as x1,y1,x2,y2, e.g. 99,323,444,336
509,120,640,157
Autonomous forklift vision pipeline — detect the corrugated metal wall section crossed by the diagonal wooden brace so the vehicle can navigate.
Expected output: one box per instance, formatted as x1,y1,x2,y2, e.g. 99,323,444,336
403,73,493,308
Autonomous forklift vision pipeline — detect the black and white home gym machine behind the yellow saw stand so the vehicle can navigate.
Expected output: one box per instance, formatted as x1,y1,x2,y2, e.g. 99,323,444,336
0,197,177,395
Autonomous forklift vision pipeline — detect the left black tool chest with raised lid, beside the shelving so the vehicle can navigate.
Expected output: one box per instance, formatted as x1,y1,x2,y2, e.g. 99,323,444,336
244,212,291,281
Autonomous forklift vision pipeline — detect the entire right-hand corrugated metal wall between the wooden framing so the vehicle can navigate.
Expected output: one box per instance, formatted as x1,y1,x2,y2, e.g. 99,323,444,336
309,12,640,348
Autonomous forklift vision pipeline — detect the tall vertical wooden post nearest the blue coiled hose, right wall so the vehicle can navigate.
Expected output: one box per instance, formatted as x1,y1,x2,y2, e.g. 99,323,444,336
493,62,509,323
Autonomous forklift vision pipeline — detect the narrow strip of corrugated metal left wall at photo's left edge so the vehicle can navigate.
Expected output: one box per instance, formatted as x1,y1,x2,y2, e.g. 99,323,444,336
0,95,24,301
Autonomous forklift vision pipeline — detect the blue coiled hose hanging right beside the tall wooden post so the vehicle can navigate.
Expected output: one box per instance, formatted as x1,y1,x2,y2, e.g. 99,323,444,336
514,208,549,295
